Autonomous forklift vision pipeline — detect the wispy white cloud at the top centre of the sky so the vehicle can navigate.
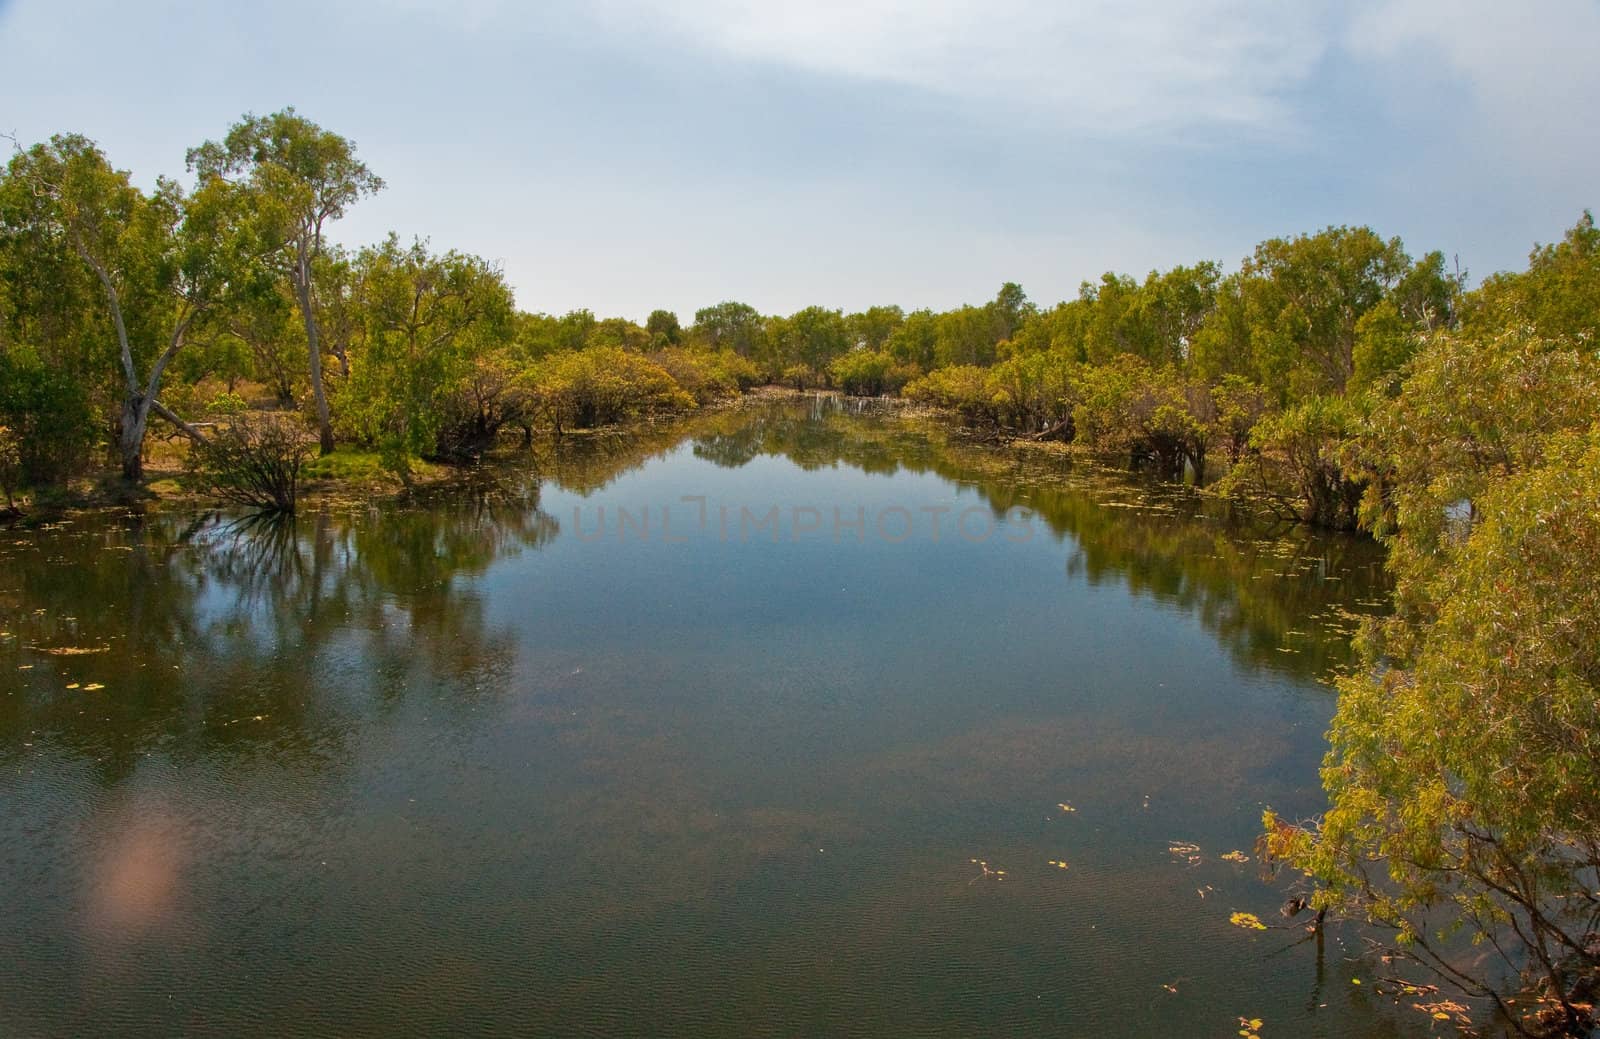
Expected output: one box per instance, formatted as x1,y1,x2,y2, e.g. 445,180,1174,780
590,0,1330,133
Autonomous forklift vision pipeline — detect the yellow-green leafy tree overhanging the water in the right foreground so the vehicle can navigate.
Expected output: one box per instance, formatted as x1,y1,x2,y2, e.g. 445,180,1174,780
1274,327,1600,1034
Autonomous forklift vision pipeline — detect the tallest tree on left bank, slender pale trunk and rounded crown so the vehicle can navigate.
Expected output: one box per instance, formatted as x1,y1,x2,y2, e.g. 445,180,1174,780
189,107,384,455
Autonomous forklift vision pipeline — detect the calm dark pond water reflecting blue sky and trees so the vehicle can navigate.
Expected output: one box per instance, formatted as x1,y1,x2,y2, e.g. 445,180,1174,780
0,403,1414,1036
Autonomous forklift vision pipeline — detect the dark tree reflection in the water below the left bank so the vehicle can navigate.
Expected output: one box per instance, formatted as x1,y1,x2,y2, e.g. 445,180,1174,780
0,477,557,780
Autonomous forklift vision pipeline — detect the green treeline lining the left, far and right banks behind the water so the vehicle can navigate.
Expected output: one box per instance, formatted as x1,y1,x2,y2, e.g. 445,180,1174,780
0,109,1594,527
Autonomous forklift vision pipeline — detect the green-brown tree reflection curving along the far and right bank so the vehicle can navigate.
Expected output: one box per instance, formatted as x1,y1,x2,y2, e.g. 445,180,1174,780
552,397,1387,676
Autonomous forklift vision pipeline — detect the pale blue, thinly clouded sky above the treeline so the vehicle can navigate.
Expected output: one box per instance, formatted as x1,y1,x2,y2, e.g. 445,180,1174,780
0,0,1600,320
